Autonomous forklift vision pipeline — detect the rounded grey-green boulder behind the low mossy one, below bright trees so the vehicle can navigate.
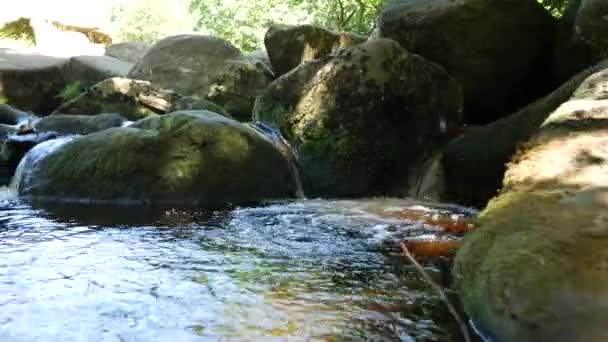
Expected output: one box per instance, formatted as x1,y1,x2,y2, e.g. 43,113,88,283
129,35,270,120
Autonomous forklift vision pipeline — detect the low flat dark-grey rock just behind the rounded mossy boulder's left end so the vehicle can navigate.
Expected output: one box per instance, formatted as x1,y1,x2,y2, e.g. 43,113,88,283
33,113,127,135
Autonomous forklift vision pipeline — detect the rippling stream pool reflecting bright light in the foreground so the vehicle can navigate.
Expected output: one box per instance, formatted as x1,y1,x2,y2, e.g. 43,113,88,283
0,193,472,342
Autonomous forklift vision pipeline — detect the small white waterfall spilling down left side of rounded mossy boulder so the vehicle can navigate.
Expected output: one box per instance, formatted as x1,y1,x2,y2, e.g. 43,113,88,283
9,135,76,194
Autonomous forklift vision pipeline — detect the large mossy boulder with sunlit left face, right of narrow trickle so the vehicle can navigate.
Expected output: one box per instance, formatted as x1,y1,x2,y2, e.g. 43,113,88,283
254,39,462,196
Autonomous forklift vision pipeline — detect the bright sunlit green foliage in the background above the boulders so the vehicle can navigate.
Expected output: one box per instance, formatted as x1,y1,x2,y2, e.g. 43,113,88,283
0,0,580,51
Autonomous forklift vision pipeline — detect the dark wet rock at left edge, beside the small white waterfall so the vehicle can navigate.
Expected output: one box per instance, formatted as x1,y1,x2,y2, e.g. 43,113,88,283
0,133,57,185
